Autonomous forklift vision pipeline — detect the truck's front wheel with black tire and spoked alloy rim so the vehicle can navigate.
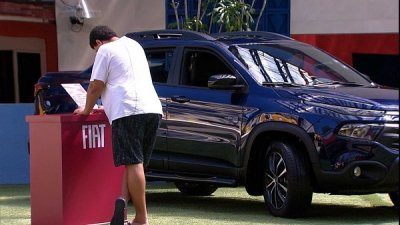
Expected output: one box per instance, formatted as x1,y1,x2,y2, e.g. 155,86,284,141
263,141,313,218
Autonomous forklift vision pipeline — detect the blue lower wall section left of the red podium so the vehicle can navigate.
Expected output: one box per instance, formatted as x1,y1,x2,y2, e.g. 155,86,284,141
0,103,33,184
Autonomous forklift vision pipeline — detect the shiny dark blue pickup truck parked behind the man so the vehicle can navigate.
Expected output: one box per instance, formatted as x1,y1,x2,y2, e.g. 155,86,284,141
35,30,399,217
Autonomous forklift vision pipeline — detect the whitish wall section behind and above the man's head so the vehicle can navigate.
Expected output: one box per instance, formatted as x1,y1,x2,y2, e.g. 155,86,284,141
56,0,165,71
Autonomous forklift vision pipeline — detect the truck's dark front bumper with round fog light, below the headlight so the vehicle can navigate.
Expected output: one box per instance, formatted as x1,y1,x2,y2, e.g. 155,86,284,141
313,120,399,194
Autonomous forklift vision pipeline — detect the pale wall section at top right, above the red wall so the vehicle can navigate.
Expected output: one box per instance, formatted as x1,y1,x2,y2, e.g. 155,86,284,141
290,0,399,34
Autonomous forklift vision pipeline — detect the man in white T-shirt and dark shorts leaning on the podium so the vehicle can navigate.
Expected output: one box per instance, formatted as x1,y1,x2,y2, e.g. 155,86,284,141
74,26,162,225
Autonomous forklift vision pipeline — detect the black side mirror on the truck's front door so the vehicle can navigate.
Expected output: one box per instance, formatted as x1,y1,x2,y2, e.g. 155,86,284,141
208,74,245,90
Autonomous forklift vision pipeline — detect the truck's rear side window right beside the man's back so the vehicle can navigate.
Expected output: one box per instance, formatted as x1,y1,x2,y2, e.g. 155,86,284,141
146,49,174,83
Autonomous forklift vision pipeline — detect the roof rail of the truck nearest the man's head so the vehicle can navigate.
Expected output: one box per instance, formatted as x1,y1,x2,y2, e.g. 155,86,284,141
125,29,215,40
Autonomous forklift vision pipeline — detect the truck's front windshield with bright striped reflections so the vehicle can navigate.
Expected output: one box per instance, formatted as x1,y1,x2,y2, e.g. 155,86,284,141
230,43,372,86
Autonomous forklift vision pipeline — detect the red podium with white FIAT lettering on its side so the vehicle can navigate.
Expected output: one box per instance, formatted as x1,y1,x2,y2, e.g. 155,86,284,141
26,113,124,225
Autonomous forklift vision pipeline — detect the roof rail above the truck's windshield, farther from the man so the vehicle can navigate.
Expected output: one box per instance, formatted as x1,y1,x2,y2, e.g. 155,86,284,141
211,31,293,40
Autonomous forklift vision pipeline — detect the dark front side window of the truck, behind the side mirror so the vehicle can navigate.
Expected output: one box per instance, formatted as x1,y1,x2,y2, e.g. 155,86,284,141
181,50,234,87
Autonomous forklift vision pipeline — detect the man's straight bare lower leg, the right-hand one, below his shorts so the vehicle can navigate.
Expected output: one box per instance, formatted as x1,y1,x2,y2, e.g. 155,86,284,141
123,163,147,224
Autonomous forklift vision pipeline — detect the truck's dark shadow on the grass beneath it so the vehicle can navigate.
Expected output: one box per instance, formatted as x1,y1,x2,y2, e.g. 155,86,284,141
147,191,399,224
